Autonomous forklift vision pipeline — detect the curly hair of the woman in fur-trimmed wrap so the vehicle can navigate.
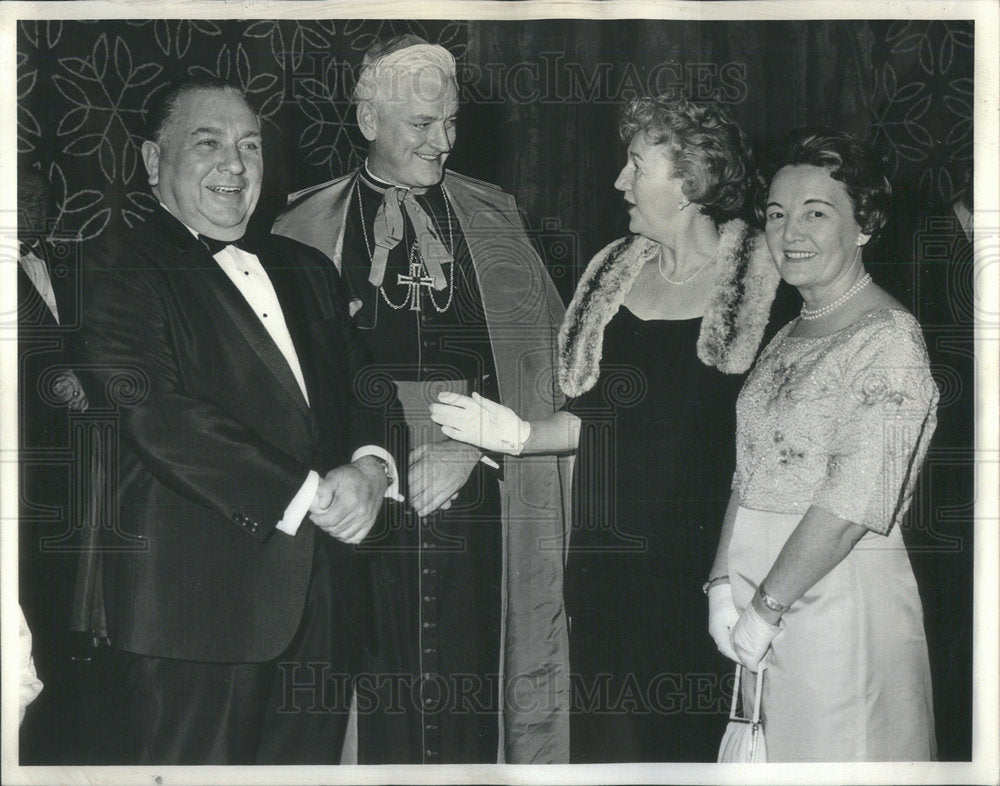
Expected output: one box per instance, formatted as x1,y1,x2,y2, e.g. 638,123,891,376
618,96,759,224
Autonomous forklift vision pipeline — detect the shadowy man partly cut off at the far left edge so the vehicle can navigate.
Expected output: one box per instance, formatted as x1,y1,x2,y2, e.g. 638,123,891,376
17,167,87,763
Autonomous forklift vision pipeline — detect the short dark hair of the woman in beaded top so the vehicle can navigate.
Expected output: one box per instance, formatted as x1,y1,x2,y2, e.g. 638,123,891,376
768,128,892,235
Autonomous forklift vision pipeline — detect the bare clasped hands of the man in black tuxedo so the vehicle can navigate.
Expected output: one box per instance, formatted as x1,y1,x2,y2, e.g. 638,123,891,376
309,456,386,544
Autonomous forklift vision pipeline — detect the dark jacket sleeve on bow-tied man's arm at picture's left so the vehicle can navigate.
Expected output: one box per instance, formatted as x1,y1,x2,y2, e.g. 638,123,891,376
77,249,309,540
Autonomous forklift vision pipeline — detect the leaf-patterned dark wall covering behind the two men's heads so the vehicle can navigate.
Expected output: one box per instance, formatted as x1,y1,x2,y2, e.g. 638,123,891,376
17,19,466,239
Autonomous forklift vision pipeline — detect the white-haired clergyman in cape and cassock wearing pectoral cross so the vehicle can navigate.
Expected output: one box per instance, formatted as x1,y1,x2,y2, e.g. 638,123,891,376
274,35,569,764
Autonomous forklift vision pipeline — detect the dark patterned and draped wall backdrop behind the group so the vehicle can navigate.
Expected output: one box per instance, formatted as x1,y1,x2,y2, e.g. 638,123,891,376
17,20,973,761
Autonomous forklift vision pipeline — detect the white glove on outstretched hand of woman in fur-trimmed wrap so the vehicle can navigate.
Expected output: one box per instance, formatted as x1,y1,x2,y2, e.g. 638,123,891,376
431,392,531,456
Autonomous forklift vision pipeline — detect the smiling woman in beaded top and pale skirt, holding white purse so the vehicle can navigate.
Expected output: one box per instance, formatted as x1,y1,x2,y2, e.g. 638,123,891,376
709,130,938,761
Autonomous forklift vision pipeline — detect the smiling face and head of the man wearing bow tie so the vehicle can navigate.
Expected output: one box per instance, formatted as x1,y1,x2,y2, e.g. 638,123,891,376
142,89,264,240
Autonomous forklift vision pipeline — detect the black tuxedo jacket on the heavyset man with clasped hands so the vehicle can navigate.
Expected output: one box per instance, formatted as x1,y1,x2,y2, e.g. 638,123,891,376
77,209,384,662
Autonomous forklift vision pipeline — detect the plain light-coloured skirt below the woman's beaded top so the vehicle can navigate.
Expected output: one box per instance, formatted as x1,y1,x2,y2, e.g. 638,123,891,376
729,507,936,761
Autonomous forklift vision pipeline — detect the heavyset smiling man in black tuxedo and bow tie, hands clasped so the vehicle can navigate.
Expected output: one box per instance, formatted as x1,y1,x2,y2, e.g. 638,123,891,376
78,79,395,764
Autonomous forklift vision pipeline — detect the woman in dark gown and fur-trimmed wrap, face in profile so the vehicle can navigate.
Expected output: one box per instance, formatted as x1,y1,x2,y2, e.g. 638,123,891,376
431,98,778,762
